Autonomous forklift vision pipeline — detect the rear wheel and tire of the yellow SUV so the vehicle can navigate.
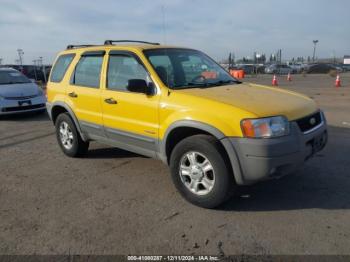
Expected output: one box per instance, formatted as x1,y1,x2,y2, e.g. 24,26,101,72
55,113,89,157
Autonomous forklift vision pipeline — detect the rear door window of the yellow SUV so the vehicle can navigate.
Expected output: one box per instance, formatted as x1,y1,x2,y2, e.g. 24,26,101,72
72,56,103,88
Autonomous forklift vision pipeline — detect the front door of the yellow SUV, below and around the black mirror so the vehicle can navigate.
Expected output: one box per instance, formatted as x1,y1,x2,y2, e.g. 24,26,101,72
101,51,160,156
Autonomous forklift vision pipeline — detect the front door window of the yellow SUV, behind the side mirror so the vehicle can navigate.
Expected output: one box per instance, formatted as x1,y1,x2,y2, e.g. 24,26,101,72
107,55,150,91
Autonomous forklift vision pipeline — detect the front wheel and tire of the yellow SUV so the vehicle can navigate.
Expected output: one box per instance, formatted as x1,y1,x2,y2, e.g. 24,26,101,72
170,135,236,208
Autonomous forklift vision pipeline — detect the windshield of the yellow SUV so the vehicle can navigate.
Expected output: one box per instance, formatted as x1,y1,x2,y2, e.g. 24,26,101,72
144,48,240,89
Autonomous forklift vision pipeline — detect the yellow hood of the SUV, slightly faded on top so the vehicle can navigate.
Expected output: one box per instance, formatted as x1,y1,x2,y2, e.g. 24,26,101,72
176,83,318,120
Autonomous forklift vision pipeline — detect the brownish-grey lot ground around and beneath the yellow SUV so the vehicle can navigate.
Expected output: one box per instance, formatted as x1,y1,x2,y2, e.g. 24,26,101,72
0,74,350,255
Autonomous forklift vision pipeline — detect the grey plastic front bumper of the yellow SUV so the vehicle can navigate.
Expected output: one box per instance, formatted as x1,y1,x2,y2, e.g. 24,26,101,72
224,117,328,184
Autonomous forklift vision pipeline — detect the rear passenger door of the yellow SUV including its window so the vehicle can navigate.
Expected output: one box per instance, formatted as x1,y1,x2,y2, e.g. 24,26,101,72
66,51,105,138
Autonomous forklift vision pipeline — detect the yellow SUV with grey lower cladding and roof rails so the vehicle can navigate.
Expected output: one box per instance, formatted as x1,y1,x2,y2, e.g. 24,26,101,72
47,40,327,208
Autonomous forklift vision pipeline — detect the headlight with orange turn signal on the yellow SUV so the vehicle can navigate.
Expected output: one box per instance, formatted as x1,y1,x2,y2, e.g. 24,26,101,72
241,116,289,138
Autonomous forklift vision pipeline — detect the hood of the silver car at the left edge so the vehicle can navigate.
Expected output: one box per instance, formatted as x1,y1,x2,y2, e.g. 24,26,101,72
0,83,38,97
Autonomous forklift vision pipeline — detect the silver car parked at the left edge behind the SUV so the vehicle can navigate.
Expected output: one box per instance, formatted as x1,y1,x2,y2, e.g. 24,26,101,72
0,68,46,115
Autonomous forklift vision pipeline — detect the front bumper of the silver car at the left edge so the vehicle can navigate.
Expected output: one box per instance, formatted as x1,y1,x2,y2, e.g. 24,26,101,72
0,95,46,115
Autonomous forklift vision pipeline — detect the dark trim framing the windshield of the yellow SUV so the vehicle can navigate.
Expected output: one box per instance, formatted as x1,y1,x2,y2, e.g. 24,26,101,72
143,47,242,90
